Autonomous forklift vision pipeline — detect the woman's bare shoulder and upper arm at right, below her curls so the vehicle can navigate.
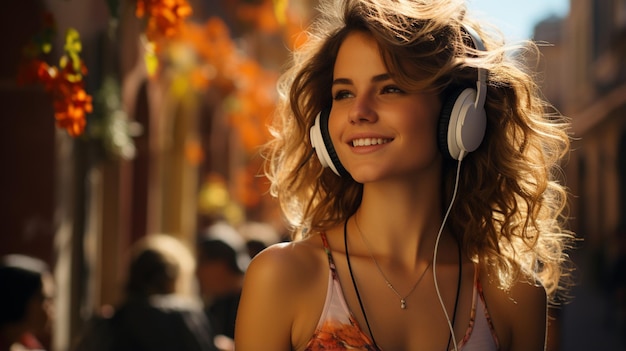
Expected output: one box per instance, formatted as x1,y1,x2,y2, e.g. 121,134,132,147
480,264,547,351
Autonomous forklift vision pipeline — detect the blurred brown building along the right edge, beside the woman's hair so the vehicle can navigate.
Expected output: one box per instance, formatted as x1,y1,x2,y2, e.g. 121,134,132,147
534,0,626,351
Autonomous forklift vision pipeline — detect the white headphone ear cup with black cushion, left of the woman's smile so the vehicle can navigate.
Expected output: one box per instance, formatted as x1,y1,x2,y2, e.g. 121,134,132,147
309,108,350,176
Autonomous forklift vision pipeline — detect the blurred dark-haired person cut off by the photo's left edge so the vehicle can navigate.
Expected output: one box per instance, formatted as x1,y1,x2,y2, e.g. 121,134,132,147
0,254,54,351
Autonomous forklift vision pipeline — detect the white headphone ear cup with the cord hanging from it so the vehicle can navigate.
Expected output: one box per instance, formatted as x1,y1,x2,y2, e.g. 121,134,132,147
438,88,487,160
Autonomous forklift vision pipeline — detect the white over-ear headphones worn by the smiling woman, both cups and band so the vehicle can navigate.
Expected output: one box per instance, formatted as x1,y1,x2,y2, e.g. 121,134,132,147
309,26,487,176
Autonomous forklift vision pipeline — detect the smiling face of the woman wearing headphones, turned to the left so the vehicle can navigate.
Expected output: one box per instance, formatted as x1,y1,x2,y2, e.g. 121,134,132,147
329,32,441,183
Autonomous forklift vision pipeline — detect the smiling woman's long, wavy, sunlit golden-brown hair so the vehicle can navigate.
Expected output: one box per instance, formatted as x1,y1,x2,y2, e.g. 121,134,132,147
264,0,574,297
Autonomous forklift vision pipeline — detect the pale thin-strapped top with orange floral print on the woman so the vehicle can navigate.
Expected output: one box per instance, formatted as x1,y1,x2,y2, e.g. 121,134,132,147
305,233,500,351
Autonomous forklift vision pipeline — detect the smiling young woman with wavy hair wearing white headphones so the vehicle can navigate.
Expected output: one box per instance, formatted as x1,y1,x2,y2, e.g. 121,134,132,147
235,0,573,351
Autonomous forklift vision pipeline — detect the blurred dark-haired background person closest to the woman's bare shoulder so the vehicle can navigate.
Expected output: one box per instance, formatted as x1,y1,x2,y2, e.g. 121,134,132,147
196,221,250,349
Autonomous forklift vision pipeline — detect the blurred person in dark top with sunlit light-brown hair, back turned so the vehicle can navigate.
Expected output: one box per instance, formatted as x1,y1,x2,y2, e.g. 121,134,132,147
77,234,217,351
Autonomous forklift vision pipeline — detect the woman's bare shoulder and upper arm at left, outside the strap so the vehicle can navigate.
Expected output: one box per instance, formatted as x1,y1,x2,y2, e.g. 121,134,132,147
235,238,323,351
